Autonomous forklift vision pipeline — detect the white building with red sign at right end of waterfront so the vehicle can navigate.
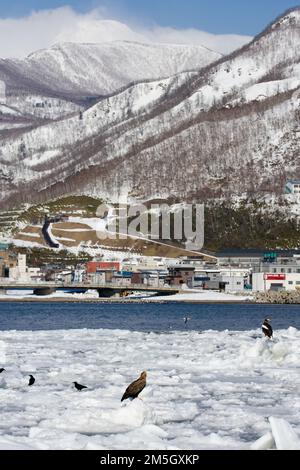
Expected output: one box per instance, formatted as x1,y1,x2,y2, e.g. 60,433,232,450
252,272,300,292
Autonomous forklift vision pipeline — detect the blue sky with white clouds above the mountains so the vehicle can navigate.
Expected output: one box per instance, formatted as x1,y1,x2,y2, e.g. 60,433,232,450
0,0,294,57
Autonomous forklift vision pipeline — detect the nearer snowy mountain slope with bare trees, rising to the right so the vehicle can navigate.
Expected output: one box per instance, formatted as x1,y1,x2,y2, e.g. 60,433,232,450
0,8,300,209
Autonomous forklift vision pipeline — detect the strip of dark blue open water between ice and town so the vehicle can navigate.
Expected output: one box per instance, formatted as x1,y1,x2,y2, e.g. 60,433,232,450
0,302,300,332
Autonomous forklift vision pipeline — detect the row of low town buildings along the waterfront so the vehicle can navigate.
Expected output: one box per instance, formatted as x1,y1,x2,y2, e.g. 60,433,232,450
0,243,300,300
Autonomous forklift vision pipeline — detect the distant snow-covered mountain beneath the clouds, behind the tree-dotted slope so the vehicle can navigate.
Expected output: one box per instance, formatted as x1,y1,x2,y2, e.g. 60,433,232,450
0,41,221,119
